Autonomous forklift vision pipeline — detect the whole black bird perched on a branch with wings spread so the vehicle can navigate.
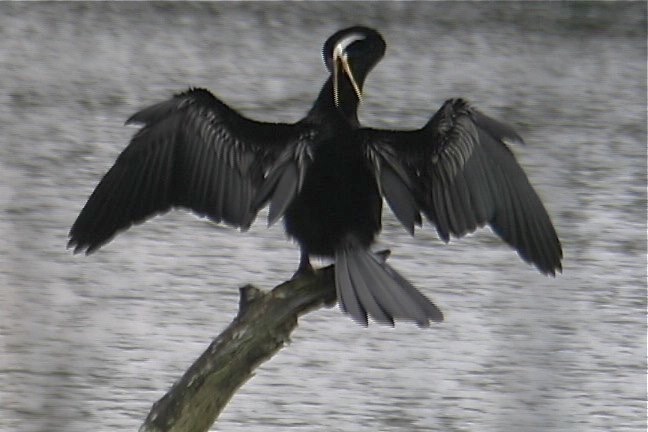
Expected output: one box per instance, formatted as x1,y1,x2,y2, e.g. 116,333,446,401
69,26,562,325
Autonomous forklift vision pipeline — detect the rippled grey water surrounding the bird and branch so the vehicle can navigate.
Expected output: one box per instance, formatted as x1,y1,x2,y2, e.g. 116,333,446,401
0,3,646,432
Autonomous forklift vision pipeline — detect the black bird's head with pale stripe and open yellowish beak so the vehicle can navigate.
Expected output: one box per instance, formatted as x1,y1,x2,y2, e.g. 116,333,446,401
323,26,386,107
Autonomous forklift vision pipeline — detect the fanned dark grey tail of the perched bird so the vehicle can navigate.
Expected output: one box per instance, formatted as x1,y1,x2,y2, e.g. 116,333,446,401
335,246,443,326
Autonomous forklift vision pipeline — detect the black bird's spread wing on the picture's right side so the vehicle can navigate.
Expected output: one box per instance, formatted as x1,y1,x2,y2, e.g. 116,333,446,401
359,99,562,274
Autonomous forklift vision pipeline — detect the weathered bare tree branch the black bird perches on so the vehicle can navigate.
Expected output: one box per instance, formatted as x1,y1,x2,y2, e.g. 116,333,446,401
139,266,336,432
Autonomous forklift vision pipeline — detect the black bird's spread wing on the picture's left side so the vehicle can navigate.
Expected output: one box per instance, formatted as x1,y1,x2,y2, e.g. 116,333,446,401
68,89,313,253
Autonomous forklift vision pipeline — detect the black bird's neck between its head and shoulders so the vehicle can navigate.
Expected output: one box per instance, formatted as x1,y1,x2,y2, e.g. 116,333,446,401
308,78,360,128
